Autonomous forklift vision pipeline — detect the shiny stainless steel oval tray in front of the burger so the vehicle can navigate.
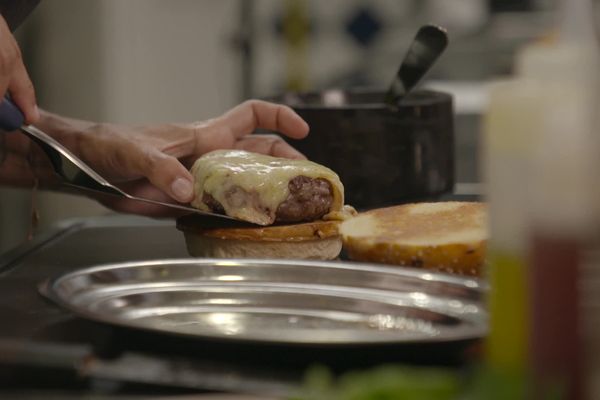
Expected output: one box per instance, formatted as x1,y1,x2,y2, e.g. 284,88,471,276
40,259,487,345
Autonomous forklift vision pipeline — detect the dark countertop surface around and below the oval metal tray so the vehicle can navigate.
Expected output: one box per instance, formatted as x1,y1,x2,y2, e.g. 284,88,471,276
0,212,478,397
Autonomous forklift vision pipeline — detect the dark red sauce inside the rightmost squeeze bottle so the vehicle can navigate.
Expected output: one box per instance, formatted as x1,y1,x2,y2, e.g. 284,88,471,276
530,234,583,400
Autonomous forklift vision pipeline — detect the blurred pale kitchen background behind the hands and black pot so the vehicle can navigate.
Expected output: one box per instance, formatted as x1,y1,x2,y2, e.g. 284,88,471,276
0,0,554,251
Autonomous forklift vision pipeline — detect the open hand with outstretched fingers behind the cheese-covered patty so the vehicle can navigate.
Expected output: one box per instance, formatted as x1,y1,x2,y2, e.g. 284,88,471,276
37,100,308,217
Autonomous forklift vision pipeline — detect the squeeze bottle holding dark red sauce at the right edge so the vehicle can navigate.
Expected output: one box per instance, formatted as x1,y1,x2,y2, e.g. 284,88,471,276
520,0,600,399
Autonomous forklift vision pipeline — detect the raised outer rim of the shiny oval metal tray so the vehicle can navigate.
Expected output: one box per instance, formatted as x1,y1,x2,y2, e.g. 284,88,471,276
38,258,488,348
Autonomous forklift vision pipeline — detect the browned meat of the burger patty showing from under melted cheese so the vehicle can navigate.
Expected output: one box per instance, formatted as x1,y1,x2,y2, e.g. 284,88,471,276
202,175,333,222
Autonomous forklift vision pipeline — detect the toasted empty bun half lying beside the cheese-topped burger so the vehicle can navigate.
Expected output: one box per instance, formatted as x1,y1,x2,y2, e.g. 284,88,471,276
340,202,488,275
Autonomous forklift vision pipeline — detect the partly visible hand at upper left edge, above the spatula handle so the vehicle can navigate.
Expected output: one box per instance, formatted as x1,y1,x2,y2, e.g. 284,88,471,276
0,16,40,124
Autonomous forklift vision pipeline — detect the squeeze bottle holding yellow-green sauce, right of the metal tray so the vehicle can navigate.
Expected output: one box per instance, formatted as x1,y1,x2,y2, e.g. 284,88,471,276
482,72,540,380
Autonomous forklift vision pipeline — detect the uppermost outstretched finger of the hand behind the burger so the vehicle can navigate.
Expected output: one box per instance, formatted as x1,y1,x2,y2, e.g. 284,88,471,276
219,100,308,139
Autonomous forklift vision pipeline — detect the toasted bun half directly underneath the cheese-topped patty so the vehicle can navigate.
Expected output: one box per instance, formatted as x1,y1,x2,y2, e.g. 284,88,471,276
177,216,342,260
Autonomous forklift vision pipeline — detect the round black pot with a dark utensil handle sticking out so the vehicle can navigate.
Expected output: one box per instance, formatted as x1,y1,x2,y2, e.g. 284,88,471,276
271,90,454,209
